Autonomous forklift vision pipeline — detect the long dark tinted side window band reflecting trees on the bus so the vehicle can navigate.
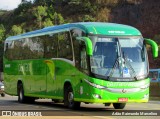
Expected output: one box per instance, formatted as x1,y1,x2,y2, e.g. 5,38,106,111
5,32,73,60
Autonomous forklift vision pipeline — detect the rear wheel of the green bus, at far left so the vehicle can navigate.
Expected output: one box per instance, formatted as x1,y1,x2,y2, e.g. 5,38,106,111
18,84,25,103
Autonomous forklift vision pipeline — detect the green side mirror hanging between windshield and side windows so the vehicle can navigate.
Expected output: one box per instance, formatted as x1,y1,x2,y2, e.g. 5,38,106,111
76,37,93,55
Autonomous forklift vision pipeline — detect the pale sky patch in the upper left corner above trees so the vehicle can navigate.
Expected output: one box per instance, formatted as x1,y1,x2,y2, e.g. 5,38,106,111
0,0,31,10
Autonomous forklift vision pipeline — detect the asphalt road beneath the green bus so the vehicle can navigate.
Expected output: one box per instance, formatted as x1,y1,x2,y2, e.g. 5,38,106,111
0,95,160,119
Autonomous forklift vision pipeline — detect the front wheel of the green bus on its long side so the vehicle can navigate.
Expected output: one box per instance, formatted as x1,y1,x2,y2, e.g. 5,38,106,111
64,86,80,109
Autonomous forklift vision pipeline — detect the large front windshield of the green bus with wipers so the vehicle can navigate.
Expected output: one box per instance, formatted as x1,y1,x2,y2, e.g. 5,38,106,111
90,36,148,81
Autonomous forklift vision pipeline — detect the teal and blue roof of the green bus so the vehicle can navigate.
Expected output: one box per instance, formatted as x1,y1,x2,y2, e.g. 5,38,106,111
6,22,141,40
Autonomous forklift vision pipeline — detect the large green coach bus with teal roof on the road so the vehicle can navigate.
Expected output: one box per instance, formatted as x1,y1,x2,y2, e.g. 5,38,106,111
4,22,158,109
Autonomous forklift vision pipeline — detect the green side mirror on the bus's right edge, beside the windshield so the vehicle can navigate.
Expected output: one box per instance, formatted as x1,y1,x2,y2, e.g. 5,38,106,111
145,39,158,58
